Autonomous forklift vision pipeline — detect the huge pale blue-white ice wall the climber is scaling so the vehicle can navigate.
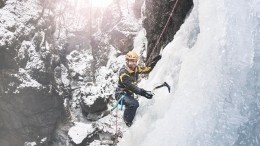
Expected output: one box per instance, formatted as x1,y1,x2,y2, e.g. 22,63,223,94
119,0,260,146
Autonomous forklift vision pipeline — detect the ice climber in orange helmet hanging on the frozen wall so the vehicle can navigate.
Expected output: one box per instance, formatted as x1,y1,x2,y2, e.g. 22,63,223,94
115,51,161,127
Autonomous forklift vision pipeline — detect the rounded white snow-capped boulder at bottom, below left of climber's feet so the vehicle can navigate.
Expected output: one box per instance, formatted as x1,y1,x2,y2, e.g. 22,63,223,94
68,122,95,144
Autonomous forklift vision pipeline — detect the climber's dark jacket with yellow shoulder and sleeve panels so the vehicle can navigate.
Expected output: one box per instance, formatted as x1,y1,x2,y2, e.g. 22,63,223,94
117,65,152,95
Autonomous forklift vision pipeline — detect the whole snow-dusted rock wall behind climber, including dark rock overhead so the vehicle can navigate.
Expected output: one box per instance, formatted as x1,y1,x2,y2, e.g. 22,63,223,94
0,0,192,146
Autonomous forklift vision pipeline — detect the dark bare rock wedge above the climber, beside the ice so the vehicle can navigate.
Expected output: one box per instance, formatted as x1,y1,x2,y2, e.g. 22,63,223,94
143,0,193,64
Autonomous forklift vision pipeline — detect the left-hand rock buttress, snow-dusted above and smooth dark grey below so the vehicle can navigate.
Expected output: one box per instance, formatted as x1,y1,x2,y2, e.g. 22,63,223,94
0,0,63,146
